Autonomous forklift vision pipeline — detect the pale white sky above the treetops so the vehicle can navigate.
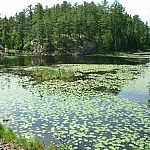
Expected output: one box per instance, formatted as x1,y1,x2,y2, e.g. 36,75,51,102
0,0,150,25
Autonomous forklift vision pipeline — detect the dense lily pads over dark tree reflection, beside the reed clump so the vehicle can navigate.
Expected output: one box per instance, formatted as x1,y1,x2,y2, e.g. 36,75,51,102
27,64,144,97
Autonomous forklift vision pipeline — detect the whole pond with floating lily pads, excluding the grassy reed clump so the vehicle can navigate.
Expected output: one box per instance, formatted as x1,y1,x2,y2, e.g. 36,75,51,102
0,56,150,150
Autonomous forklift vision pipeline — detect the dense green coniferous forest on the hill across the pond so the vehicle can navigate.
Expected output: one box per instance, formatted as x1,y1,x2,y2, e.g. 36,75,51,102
0,0,150,53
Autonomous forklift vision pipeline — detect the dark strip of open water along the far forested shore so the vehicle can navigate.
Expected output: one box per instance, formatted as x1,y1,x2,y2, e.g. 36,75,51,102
0,56,149,67
